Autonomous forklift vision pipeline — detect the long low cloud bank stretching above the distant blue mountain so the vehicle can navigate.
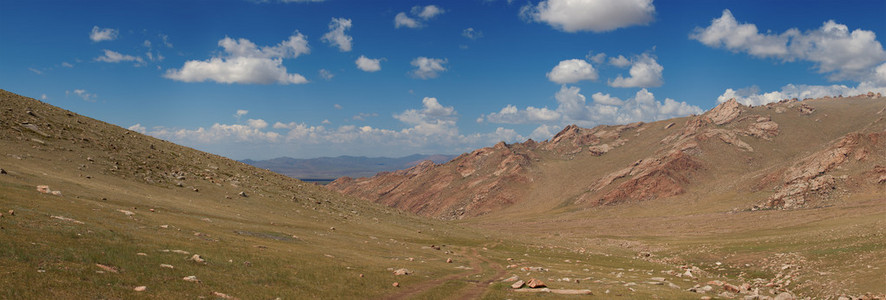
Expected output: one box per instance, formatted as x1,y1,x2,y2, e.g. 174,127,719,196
138,97,525,158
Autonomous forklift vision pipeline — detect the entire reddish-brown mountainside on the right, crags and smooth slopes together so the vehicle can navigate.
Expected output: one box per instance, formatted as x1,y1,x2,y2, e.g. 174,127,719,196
329,94,886,219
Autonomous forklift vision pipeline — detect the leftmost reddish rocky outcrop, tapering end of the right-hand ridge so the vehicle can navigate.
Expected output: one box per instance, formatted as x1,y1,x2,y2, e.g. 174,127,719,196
327,141,538,219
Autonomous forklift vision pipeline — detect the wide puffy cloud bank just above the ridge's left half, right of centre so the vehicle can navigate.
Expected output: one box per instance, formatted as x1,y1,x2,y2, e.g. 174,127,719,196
486,85,703,129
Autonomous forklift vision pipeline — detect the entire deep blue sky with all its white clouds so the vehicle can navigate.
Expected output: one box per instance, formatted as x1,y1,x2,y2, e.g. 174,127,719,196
0,0,886,159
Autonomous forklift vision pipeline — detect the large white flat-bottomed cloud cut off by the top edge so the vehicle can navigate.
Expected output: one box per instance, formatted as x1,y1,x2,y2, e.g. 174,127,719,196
520,0,655,32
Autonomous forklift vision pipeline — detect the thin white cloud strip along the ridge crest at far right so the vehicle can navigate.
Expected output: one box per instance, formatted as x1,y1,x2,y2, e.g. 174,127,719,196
717,82,886,105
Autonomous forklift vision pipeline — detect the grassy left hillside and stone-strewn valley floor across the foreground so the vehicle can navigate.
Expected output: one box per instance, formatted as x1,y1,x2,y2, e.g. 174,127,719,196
0,91,886,299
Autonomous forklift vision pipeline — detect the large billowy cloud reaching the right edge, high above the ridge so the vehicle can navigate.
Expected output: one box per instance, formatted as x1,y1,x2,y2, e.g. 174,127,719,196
689,9,886,81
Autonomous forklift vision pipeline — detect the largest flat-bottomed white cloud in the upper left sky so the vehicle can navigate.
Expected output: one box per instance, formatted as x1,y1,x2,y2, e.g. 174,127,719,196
163,33,310,84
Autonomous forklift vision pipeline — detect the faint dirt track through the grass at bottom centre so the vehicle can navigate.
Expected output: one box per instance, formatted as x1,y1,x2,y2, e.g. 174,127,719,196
385,248,505,299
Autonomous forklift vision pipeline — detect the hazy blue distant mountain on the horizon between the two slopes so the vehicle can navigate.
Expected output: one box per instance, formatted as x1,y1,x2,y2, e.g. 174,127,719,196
241,154,455,179
